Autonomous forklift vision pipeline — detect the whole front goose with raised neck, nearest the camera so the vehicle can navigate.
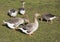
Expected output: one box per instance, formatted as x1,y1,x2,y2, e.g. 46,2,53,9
18,13,39,36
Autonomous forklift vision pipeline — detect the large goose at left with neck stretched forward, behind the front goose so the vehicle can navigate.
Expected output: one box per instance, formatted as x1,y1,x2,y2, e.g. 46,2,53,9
3,18,29,29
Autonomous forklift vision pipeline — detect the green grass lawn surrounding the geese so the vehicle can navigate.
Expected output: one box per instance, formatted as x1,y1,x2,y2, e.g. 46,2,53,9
0,0,60,42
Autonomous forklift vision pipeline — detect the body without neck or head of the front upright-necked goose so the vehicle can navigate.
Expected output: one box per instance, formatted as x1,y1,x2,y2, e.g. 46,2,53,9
19,23,38,34
